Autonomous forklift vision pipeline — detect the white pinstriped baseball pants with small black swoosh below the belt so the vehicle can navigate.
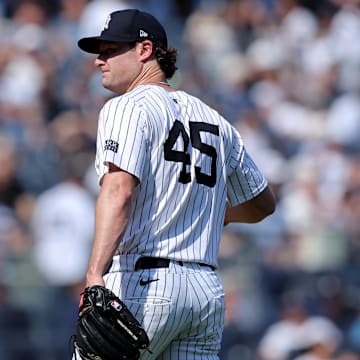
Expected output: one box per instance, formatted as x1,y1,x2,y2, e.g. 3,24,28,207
104,260,225,360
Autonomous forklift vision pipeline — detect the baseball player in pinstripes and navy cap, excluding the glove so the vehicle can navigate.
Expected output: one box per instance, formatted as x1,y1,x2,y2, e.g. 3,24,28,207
78,9,275,360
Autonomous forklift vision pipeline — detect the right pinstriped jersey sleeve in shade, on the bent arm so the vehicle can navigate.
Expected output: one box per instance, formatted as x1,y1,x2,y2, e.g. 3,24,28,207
227,127,268,206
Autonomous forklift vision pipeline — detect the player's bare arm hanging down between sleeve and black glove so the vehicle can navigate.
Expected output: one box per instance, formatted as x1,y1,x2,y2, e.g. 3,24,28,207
86,164,138,286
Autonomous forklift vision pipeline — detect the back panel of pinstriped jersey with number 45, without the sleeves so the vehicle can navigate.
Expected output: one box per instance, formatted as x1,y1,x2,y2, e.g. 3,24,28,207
121,86,240,265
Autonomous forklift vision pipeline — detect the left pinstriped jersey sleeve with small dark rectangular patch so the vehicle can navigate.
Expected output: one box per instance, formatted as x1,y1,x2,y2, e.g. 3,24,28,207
96,97,147,182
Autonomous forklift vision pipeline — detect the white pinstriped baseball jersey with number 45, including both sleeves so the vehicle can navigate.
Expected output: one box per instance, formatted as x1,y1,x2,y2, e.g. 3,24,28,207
95,85,267,267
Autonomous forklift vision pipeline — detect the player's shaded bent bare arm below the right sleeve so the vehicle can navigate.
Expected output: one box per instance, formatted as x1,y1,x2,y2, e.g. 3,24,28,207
224,187,275,225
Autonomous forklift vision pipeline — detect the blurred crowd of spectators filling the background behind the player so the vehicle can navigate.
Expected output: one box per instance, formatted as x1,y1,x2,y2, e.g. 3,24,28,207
0,0,360,360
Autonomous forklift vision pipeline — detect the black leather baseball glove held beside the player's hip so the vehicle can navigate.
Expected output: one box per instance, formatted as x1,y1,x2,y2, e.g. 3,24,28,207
74,286,149,360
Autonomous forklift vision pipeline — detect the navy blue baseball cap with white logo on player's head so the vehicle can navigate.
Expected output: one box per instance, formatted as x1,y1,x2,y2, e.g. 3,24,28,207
78,9,167,54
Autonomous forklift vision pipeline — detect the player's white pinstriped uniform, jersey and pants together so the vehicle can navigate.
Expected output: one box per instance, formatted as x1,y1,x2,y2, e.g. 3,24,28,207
96,85,267,360
